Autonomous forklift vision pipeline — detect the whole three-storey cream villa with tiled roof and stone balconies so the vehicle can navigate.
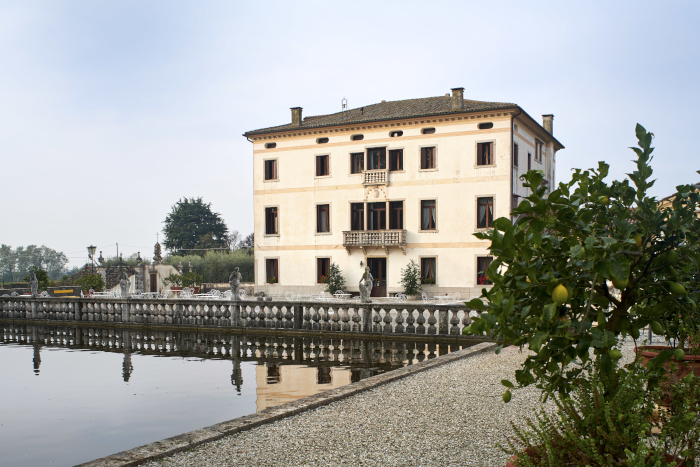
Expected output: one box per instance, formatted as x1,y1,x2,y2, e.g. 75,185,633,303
244,88,564,298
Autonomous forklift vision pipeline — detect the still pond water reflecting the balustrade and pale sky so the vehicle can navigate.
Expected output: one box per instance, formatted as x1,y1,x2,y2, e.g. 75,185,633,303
0,324,470,467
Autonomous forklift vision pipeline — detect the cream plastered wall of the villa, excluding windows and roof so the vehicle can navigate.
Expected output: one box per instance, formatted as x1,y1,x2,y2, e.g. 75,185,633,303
254,114,556,297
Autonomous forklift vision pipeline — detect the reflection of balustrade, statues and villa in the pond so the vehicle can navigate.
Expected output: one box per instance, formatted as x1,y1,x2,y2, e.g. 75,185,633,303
0,324,469,411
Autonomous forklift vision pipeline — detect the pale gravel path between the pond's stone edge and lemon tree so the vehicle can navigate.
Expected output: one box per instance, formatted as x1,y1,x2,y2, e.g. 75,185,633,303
146,345,633,467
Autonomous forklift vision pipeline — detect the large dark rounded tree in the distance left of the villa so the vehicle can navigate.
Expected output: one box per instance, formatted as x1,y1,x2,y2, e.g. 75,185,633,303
163,198,228,255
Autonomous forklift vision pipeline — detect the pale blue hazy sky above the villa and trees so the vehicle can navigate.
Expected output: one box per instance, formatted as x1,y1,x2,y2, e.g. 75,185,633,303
0,0,700,265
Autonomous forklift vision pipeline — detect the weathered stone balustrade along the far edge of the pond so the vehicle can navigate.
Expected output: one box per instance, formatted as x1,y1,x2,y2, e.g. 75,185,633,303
0,297,476,336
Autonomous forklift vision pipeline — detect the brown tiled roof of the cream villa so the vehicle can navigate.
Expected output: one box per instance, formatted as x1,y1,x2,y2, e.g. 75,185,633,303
244,96,517,136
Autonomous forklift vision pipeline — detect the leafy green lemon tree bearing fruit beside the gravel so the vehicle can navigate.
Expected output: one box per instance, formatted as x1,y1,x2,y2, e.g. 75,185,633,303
465,125,700,399
